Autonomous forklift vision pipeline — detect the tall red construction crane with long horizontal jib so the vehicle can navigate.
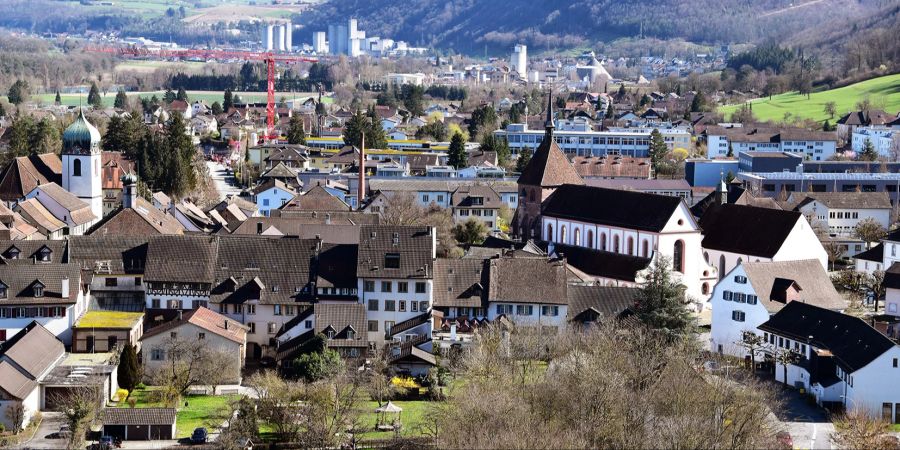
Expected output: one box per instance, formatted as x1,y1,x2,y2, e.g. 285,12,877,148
84,45,319,140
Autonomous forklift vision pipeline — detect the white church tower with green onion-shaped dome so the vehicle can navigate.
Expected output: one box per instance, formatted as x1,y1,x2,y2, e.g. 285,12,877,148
62,110,103,217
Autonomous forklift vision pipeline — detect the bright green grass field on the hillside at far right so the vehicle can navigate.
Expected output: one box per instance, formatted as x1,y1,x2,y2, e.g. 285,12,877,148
719,74,900,123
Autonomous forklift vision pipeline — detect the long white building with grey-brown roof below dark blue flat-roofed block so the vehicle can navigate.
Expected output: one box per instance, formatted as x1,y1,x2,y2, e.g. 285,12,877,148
788,192,893,236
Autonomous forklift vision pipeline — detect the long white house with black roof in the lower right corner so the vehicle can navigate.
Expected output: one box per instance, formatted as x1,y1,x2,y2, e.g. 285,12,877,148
759,301,900,423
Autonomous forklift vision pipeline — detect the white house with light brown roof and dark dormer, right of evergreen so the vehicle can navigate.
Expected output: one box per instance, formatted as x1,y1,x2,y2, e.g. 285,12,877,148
707,259,846,357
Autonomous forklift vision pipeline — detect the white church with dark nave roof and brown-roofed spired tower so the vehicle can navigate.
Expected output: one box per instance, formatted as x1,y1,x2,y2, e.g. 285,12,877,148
513,96,718,305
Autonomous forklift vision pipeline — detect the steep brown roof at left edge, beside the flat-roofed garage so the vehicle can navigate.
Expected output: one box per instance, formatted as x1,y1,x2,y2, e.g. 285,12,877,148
0,321,66,380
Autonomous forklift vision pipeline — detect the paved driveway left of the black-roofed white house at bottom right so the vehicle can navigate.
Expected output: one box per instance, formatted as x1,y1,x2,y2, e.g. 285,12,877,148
775,384,834,449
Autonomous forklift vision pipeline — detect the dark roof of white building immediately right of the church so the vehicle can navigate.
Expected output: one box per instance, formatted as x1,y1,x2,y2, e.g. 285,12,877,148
700,204,802,258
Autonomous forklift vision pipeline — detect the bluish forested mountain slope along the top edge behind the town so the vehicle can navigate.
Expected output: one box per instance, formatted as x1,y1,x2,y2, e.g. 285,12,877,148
298,0,896,53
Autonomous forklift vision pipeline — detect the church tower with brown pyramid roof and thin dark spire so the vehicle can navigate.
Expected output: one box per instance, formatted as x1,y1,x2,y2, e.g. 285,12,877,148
513,92,584,241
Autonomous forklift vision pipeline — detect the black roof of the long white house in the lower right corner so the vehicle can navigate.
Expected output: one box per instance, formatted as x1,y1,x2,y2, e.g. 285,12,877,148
759,302,896,373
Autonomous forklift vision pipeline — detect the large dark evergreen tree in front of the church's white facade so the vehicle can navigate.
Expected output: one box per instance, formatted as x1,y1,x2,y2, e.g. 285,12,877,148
634,256,694,339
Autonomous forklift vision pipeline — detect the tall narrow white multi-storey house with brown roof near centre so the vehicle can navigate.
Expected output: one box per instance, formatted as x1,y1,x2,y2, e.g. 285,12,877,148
356,225,437,347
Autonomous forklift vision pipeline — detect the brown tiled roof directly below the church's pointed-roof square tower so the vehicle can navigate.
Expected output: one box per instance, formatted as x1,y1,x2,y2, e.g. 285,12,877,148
488,256,569,305
